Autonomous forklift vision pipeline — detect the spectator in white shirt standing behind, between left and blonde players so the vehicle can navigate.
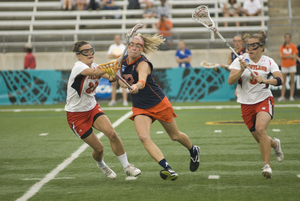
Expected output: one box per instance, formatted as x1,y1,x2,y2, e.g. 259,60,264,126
107,35,128,106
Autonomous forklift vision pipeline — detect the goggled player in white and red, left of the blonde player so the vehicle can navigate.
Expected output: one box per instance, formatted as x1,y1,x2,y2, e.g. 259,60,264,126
65,41,141,179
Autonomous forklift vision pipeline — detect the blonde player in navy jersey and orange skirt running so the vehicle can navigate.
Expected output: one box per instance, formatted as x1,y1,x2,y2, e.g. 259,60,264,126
119,34,200,180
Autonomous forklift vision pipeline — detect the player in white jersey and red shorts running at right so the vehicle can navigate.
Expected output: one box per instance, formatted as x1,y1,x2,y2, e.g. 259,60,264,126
228,31,284,178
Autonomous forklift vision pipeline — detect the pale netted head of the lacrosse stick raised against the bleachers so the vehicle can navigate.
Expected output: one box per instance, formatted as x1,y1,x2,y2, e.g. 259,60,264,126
192,5,215,29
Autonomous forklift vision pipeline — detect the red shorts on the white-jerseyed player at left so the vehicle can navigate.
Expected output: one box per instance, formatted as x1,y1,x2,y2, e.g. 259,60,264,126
67,103,104,139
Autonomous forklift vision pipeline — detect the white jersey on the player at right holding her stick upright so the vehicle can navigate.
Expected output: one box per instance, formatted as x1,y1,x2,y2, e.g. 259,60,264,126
229,53,280,104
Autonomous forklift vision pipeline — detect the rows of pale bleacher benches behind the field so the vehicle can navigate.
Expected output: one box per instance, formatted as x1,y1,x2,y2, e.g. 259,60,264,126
0,0,269,52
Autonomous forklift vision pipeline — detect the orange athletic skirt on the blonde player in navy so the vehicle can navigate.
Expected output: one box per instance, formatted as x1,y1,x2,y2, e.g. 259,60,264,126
129,96,177,123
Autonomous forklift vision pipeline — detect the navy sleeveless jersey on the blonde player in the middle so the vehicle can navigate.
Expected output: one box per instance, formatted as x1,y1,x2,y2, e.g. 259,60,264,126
121,55,165,109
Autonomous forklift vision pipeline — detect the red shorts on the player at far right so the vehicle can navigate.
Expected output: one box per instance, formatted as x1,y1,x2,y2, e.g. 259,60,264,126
241,97,274,132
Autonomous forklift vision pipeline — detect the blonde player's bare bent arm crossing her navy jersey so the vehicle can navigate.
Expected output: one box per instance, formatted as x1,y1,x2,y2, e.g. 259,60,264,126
130,61,151,94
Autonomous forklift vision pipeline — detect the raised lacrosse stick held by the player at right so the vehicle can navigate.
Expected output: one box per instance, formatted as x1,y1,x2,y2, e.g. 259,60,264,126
192,5,256,76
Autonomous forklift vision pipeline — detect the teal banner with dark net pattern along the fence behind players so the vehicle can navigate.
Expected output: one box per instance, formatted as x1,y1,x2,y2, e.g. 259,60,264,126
0,68,300,105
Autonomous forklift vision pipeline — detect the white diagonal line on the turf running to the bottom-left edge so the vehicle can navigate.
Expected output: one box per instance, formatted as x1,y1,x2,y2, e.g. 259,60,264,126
16,111,132,201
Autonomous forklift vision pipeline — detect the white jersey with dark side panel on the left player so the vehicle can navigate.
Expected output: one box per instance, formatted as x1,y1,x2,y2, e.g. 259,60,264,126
65,61,99,112
